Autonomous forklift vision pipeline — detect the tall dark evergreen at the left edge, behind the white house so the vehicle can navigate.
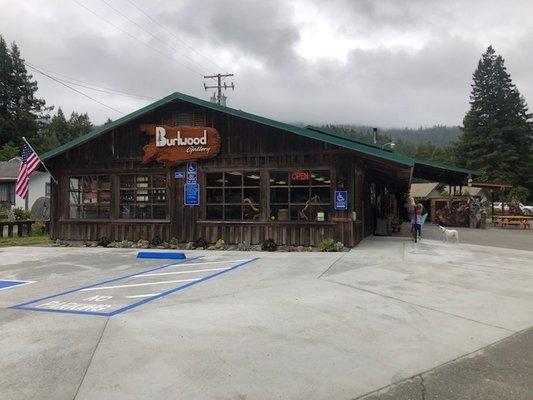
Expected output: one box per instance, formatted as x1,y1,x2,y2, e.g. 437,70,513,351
0,35,50,155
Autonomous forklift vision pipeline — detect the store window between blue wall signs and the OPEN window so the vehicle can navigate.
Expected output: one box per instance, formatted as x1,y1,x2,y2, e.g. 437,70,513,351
206,171,261,220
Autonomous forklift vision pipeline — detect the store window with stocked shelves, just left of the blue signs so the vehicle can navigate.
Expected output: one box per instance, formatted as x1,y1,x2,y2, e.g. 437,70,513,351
119,174,168,219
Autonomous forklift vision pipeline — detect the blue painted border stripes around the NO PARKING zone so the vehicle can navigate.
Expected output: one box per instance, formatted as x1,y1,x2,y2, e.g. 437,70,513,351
10,257,259,317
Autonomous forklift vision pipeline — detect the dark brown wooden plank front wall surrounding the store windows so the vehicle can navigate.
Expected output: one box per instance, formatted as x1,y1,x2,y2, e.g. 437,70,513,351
44,103,382,246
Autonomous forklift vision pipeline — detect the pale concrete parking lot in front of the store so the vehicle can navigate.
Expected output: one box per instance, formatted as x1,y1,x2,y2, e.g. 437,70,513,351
0,238,533,400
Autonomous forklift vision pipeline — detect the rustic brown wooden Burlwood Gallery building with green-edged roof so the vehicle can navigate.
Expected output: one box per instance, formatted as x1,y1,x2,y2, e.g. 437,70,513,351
42,93,424,246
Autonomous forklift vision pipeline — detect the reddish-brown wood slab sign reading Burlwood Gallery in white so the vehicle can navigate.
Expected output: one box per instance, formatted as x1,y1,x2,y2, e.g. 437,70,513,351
140,125,220,166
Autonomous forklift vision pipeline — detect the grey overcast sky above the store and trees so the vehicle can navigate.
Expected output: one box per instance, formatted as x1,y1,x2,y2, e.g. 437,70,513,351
0,0,533,127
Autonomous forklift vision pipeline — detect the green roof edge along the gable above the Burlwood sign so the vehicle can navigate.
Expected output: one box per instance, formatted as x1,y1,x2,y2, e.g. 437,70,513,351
41,92,414,167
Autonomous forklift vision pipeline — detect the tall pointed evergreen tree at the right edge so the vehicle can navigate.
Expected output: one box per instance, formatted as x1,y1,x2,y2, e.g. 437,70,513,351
456,46,533,194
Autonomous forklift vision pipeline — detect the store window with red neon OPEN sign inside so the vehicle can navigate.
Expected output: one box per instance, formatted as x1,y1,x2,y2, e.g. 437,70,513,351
270,170,331,221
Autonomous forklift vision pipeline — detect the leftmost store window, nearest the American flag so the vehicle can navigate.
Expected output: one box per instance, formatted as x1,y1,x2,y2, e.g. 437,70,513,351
69,175,111,219
